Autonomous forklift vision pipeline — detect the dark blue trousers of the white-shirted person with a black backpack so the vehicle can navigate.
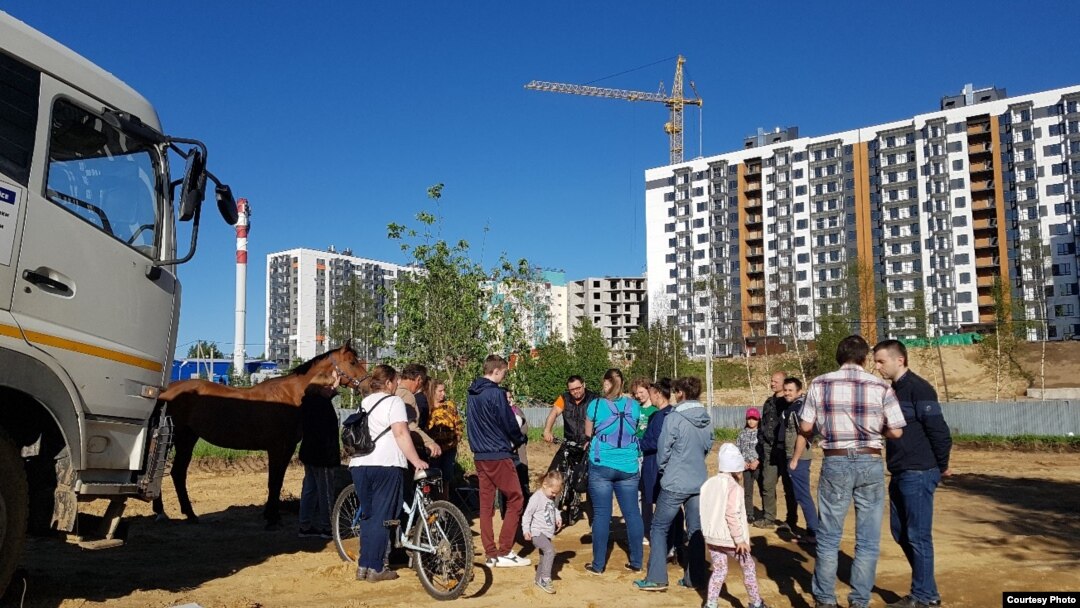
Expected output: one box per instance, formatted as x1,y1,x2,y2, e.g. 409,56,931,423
349,467,404,572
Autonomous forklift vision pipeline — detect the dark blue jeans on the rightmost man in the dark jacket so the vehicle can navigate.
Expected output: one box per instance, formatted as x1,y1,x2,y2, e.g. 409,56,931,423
889,469,942,604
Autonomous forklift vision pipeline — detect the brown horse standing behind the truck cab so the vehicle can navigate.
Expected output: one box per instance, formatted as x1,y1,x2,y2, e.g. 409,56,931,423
153,342,367,528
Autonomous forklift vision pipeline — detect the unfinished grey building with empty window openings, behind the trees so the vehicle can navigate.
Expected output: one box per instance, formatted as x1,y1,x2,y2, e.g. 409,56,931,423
566,276,648,350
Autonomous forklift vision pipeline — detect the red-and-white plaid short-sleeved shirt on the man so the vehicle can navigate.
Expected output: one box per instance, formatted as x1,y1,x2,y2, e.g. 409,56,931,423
799,363,906,449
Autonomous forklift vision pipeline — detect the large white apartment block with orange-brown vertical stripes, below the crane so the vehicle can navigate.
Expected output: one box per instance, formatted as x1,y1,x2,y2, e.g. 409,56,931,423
645,81,1080,356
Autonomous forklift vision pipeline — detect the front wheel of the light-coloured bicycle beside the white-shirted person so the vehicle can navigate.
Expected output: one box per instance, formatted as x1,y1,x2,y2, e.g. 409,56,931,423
413,500,474,599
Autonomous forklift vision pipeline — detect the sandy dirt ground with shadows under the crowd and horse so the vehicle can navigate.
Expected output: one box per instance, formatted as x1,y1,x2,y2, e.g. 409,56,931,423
9,445,1080,608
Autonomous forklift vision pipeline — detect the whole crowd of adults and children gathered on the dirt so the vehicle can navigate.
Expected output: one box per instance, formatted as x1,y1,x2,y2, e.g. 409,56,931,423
300,336,951,608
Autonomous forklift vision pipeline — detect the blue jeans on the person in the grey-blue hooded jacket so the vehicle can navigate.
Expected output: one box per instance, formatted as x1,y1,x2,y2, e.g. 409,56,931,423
645,489,706,586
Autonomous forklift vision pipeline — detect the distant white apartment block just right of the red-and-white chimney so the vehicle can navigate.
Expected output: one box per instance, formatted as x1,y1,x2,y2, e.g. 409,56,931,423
266,247,410,365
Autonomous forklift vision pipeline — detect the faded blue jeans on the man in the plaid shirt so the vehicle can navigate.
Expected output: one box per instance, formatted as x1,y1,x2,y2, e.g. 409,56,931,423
811,454,885,606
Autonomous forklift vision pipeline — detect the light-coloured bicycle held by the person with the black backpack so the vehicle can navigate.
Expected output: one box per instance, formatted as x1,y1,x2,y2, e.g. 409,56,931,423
330,469,474,600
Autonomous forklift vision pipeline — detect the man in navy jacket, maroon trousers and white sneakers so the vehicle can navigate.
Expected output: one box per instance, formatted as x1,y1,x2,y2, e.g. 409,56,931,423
465,354,531,568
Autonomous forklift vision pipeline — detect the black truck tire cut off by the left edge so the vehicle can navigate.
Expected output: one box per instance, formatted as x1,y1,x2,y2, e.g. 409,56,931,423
0,430,29,597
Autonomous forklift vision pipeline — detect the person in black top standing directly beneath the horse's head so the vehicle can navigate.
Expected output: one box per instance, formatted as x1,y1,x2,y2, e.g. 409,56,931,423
299,371,341,539
